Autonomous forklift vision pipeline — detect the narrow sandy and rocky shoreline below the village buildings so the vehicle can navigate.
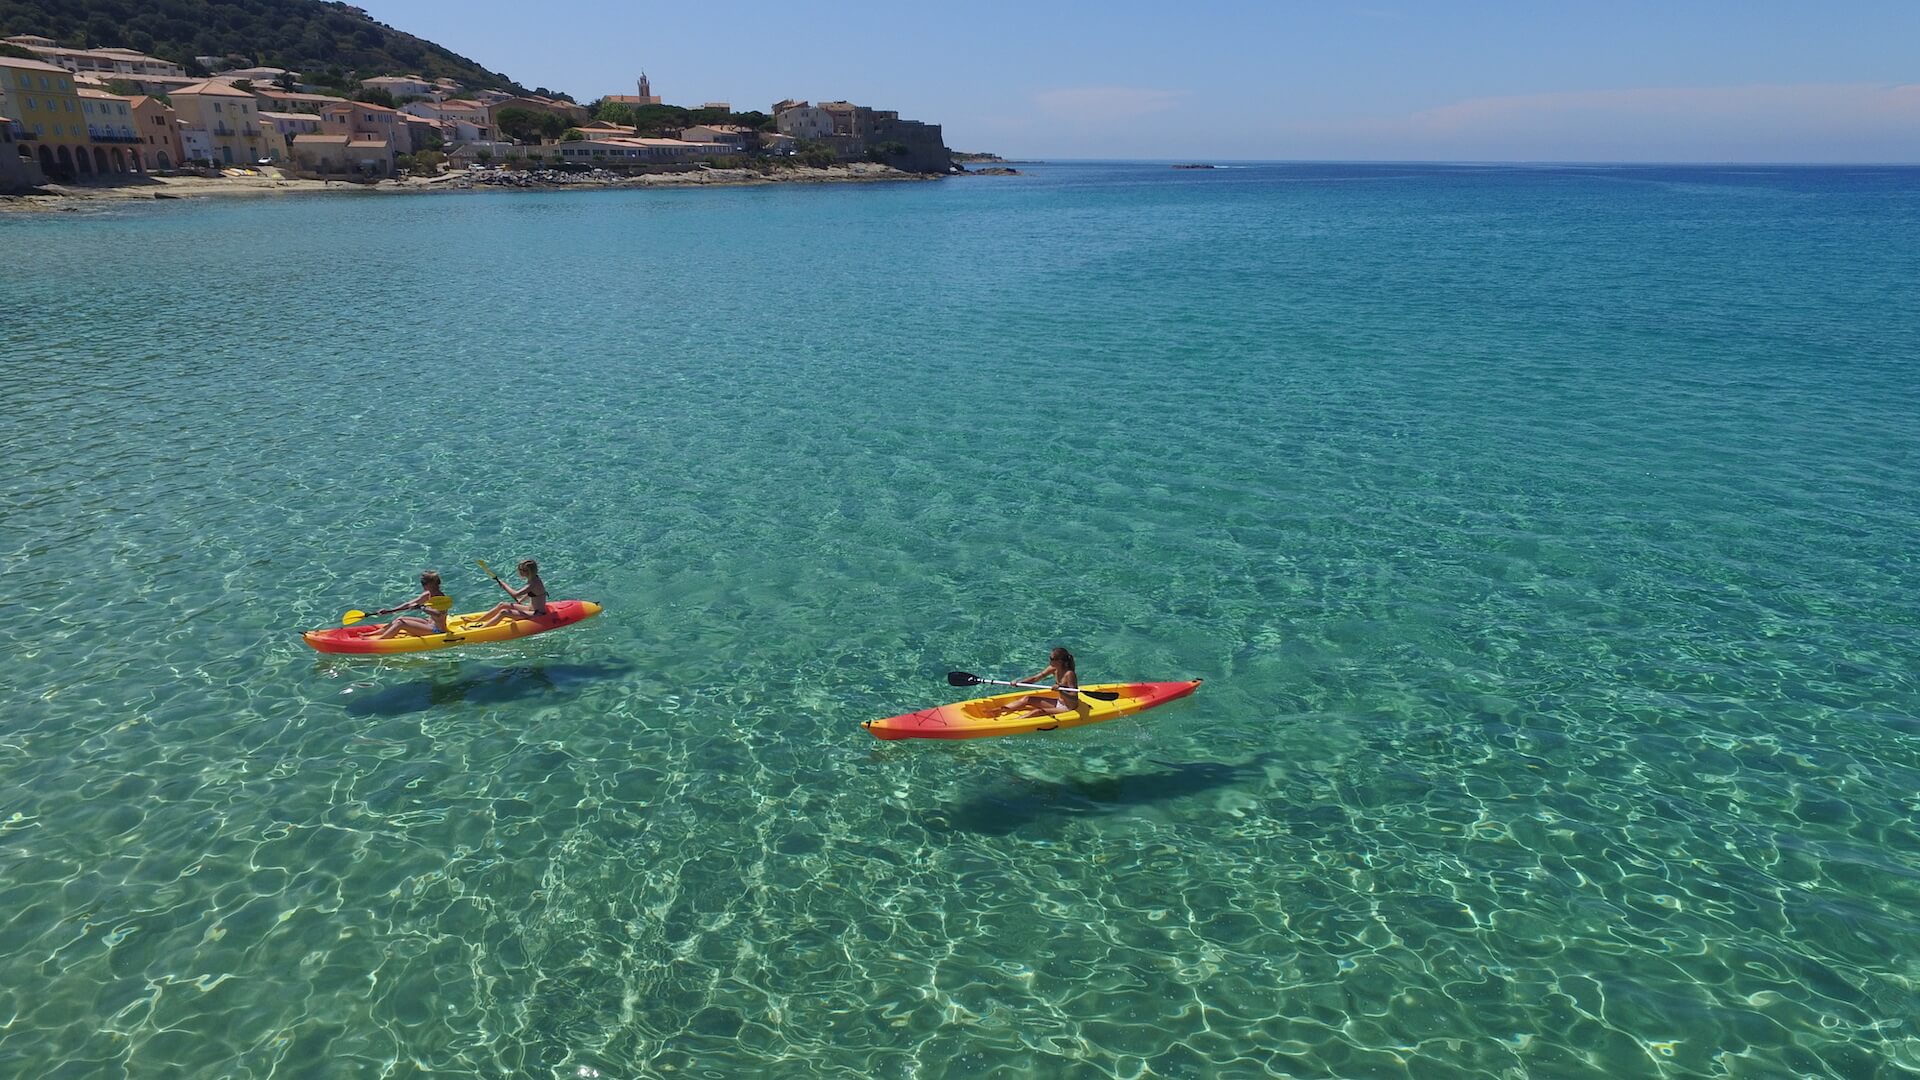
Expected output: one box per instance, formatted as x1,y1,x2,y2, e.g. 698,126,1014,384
0,161,935,213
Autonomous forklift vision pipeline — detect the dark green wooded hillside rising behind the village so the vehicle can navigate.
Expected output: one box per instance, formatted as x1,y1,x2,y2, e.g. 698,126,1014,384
0,0,520,88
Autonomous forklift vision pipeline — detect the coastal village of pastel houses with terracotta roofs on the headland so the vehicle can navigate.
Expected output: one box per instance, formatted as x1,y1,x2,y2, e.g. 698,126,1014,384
0,35,958,194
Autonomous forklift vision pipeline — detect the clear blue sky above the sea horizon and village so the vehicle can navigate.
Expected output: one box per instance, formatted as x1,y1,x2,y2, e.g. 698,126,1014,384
361,0,1920,161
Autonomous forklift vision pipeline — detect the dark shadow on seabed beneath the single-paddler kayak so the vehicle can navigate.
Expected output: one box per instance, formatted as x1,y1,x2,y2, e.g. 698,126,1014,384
927,753,1273,836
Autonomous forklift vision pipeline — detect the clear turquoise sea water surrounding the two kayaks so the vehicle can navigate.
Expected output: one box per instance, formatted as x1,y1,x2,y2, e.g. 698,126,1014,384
0,165,1920,1076
